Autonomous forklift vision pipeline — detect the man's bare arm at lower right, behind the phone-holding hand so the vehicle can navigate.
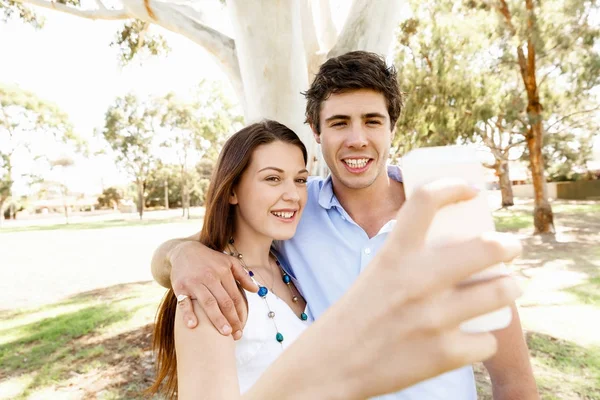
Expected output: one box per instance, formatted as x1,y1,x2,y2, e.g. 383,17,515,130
484,304,540,400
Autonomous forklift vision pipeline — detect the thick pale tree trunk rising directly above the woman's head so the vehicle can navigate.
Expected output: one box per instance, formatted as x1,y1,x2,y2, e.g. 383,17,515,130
227,0,316,155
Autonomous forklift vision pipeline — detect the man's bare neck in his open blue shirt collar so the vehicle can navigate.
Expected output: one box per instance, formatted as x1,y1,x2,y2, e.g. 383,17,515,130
332,172,404,237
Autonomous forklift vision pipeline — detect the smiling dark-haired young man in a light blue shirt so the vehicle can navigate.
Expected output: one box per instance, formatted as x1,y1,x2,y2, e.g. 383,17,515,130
153,52,538,400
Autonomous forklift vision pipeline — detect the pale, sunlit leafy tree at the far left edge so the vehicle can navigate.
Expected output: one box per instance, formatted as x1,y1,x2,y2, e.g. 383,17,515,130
0,85,85,225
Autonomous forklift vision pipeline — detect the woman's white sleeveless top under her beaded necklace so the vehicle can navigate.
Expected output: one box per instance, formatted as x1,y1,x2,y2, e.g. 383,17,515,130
235,290,311,393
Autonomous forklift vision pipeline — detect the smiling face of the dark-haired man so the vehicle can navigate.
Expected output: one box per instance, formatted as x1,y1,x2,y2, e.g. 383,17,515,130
313,89,394,189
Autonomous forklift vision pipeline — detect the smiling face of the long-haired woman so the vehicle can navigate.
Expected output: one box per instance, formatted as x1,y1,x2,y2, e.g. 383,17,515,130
229,141,308,240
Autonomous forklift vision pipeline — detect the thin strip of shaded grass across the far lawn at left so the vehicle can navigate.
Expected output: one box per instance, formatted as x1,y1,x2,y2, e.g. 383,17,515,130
0,216,202,234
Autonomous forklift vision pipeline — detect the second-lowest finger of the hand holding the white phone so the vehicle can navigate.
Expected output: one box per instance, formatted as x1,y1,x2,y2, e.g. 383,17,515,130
437,276,522,327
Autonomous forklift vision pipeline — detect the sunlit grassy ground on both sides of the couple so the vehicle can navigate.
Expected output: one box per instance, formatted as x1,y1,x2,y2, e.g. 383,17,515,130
0,202,600,400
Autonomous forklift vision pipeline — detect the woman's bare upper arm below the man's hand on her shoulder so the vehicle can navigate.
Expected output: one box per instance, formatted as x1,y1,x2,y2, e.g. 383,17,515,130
175,300,241,400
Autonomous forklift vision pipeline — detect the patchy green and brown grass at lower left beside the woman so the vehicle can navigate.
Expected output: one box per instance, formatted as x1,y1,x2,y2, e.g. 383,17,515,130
0,283,164,399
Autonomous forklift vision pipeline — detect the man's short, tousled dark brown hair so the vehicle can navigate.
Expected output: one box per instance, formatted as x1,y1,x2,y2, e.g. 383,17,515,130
303,51,403,133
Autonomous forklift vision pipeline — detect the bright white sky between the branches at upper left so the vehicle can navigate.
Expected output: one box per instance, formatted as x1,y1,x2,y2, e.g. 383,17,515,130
0,2,235,195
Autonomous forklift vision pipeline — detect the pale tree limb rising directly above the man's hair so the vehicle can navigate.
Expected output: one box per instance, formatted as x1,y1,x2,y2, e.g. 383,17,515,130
327,0,403,58
